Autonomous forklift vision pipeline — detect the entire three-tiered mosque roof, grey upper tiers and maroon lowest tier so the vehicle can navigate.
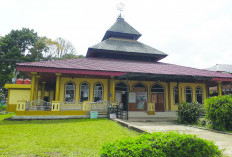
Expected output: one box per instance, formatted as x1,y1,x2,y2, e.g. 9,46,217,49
17,17,232,82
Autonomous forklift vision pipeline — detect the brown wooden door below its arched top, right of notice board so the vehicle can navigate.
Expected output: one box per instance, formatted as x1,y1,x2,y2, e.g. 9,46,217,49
151,93,165,112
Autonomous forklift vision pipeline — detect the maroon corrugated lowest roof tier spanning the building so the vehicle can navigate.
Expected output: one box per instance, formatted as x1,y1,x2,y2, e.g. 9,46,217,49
17,58,232,78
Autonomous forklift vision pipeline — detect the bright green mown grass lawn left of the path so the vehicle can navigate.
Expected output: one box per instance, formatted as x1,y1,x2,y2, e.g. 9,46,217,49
0,114,138,156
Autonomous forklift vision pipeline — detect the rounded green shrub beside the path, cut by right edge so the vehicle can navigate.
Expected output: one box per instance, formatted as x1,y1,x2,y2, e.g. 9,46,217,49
205,95,232,130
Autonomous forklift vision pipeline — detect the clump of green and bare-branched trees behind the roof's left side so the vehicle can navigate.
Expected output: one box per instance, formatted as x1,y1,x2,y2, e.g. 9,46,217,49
0,28,78,94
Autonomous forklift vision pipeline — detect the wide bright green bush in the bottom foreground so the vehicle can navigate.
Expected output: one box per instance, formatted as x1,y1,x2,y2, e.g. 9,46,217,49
100,132,222,157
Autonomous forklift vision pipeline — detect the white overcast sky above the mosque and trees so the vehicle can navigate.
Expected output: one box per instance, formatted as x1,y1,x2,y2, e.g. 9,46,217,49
0,0,232,68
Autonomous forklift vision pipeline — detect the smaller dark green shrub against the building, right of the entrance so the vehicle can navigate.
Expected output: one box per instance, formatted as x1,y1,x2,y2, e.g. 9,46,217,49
177,102,203,124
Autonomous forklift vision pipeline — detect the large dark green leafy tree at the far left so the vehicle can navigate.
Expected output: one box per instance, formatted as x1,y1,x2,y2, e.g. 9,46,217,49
0,28,61,89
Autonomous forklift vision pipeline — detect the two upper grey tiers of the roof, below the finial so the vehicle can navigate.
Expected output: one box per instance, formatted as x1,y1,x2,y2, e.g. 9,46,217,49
86,17,167,61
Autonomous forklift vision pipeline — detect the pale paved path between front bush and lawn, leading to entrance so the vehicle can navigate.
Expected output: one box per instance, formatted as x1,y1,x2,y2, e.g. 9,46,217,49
122,122,232,157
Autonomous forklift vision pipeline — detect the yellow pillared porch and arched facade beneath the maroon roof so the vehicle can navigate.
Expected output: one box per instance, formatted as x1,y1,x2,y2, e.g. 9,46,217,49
11,69,231,118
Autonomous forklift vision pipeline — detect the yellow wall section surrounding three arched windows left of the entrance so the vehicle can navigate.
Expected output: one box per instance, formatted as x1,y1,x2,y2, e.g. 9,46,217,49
59,77,108,102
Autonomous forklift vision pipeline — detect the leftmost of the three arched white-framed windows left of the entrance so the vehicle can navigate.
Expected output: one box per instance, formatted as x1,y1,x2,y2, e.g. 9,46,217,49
65,82,75,102
